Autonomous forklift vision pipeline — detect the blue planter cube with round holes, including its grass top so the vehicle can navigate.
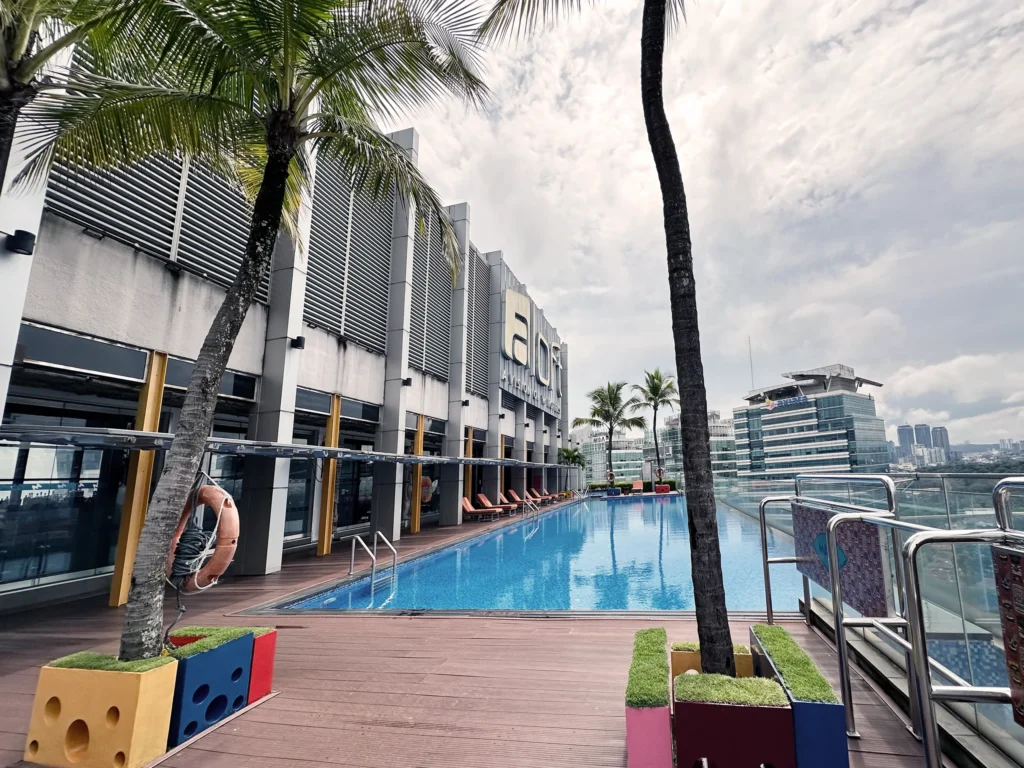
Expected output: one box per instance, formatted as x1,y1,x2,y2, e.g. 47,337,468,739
167,627,253,750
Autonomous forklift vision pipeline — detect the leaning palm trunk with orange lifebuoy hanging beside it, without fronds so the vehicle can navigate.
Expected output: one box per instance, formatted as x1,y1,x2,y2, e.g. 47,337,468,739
120,144,294,662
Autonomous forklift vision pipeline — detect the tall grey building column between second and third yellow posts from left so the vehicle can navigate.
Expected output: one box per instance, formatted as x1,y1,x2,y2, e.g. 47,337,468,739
371,128,420,542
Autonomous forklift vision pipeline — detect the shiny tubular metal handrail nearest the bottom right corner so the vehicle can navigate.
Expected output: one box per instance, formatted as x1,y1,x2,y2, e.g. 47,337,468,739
903,528,1024,768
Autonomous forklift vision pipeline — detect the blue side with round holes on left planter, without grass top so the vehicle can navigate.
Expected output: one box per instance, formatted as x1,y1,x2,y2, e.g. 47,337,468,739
167,635,253,750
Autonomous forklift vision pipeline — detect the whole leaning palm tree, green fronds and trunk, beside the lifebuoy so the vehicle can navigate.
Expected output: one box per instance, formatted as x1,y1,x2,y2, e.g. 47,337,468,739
24,0,486,660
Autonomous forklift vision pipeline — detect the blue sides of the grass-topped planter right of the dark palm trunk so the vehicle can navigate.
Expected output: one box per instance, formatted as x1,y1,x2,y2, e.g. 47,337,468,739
751,629,850,768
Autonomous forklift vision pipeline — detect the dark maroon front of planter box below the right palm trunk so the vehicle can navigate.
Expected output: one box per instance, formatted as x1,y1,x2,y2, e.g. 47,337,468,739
672,701,794,768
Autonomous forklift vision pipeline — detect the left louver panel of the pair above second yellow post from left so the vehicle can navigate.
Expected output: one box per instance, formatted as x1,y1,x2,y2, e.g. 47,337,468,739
303,161,352,335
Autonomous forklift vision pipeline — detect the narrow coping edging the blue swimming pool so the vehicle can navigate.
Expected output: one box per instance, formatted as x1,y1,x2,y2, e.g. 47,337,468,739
235,494,803,622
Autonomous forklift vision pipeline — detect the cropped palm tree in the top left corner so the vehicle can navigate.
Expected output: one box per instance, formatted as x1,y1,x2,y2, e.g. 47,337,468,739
0,0,140,189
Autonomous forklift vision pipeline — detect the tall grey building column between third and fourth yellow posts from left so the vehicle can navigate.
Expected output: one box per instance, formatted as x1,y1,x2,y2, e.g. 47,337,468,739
440,203,470,525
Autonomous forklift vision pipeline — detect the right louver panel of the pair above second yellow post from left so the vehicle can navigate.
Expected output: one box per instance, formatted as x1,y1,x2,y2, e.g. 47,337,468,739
342,186,394,353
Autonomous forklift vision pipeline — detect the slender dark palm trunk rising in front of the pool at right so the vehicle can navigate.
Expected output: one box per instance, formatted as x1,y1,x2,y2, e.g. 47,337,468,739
640,0,735,675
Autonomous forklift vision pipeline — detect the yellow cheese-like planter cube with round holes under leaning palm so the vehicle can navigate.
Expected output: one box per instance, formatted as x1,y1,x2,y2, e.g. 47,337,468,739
25,651,178,768
